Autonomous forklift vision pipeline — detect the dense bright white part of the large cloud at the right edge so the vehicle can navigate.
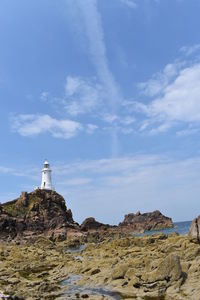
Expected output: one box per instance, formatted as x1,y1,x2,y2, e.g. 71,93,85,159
145,64,200,122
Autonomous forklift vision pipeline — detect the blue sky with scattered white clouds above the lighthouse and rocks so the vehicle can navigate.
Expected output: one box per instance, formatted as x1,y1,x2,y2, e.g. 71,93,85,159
0,0,200,224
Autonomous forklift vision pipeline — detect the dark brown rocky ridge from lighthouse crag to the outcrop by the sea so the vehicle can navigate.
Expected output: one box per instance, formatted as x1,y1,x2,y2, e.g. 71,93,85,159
0,189,173,240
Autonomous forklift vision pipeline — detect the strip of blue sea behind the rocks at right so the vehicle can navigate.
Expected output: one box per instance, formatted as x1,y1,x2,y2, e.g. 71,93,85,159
139,221,192,236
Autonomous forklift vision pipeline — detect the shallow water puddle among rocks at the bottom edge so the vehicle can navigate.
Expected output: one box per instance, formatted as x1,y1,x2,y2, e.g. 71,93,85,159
61,275,121,300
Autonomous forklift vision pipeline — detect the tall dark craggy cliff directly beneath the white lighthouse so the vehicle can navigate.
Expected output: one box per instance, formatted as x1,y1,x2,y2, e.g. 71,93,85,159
0,189,75,238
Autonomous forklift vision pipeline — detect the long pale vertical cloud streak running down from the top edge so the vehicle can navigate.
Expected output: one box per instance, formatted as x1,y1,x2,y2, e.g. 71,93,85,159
69,0,121,154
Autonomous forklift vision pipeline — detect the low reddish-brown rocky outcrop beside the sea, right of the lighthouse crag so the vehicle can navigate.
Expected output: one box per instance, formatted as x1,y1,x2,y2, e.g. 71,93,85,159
119,210,174,232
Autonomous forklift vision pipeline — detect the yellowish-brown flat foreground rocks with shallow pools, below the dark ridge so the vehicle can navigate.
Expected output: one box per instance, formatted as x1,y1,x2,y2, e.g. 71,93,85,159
0,231,200,300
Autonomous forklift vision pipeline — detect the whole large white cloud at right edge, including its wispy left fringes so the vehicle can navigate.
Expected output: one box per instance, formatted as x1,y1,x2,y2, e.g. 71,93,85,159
134,57,200,133
